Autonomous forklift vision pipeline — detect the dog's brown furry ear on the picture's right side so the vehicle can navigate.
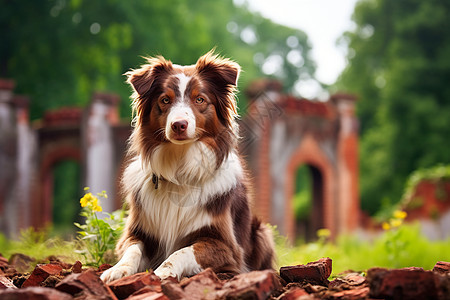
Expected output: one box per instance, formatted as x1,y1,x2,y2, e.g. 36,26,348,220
195,50,241,126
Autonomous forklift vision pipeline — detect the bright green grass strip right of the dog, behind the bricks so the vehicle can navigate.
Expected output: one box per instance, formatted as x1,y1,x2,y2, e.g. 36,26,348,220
276,224,450,275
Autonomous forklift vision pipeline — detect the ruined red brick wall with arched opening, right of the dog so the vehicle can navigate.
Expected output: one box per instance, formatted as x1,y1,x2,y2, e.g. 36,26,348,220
241,81,359,240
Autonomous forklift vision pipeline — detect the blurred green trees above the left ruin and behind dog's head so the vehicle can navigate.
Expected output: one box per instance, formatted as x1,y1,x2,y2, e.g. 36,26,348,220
0,0,315,119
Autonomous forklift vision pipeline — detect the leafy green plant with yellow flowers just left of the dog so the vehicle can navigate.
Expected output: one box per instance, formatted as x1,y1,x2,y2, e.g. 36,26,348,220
74,188,125,265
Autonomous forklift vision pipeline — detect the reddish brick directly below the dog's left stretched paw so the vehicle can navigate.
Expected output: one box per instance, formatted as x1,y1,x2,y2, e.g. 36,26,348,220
108,272,161,299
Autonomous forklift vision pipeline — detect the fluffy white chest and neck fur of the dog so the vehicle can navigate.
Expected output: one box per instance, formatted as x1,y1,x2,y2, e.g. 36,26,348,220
123,142,243,254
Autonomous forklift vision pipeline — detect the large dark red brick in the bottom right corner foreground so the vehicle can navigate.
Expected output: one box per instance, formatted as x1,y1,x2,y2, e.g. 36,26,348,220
367,268,438,299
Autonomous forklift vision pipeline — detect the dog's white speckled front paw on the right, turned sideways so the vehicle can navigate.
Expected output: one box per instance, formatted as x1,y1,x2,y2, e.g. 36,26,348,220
155,246,203,280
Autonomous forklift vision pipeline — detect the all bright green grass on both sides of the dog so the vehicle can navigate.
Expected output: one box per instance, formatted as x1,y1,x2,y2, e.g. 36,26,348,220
0,224,450,275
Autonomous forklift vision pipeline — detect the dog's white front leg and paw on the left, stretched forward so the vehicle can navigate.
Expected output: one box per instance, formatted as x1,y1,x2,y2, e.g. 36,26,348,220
100,242,148,282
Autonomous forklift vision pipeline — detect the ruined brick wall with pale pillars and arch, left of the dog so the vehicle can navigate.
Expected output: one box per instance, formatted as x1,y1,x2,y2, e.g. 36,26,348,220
0,80,131,236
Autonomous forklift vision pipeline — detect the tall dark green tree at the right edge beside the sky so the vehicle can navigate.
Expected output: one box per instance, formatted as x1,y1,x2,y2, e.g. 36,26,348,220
336,0,450,214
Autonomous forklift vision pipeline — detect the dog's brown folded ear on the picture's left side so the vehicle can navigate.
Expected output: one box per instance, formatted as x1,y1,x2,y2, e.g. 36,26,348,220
125,56,173,97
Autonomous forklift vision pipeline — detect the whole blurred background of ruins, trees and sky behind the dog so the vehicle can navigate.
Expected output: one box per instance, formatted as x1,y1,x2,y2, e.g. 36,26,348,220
0,0,450,253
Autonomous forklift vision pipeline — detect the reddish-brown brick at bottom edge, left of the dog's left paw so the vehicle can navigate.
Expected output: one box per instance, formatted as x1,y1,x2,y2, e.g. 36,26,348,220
55,269,117,300
